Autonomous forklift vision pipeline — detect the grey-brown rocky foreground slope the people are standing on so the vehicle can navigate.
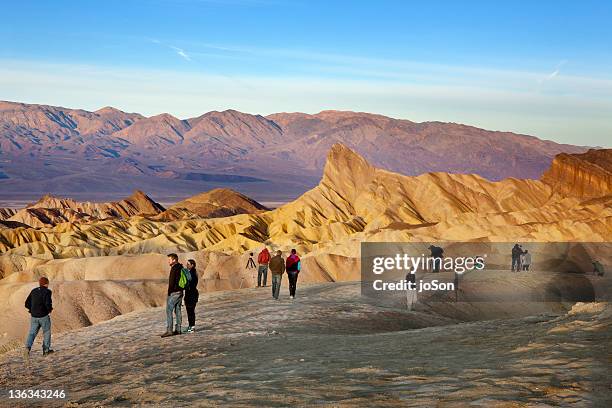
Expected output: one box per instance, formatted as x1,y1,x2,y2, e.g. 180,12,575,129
0,281,612,407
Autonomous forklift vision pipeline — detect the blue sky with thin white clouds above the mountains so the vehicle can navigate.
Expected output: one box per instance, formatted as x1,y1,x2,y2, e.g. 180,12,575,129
0,0,612,146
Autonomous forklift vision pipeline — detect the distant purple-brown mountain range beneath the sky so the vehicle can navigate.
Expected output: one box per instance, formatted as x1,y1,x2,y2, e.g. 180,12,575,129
0,102,587,201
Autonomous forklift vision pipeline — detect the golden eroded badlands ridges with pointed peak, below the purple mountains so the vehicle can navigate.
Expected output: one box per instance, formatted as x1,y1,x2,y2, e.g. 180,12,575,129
0,144,612,350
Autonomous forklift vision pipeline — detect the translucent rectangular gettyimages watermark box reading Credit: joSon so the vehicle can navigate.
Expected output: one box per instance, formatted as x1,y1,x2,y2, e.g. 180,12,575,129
361,241,612,304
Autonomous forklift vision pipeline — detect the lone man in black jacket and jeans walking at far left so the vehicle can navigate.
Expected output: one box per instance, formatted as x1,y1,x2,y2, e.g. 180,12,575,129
25,276,53,356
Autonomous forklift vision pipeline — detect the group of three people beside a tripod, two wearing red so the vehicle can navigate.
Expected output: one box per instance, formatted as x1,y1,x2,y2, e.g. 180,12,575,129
246,247,302,300
